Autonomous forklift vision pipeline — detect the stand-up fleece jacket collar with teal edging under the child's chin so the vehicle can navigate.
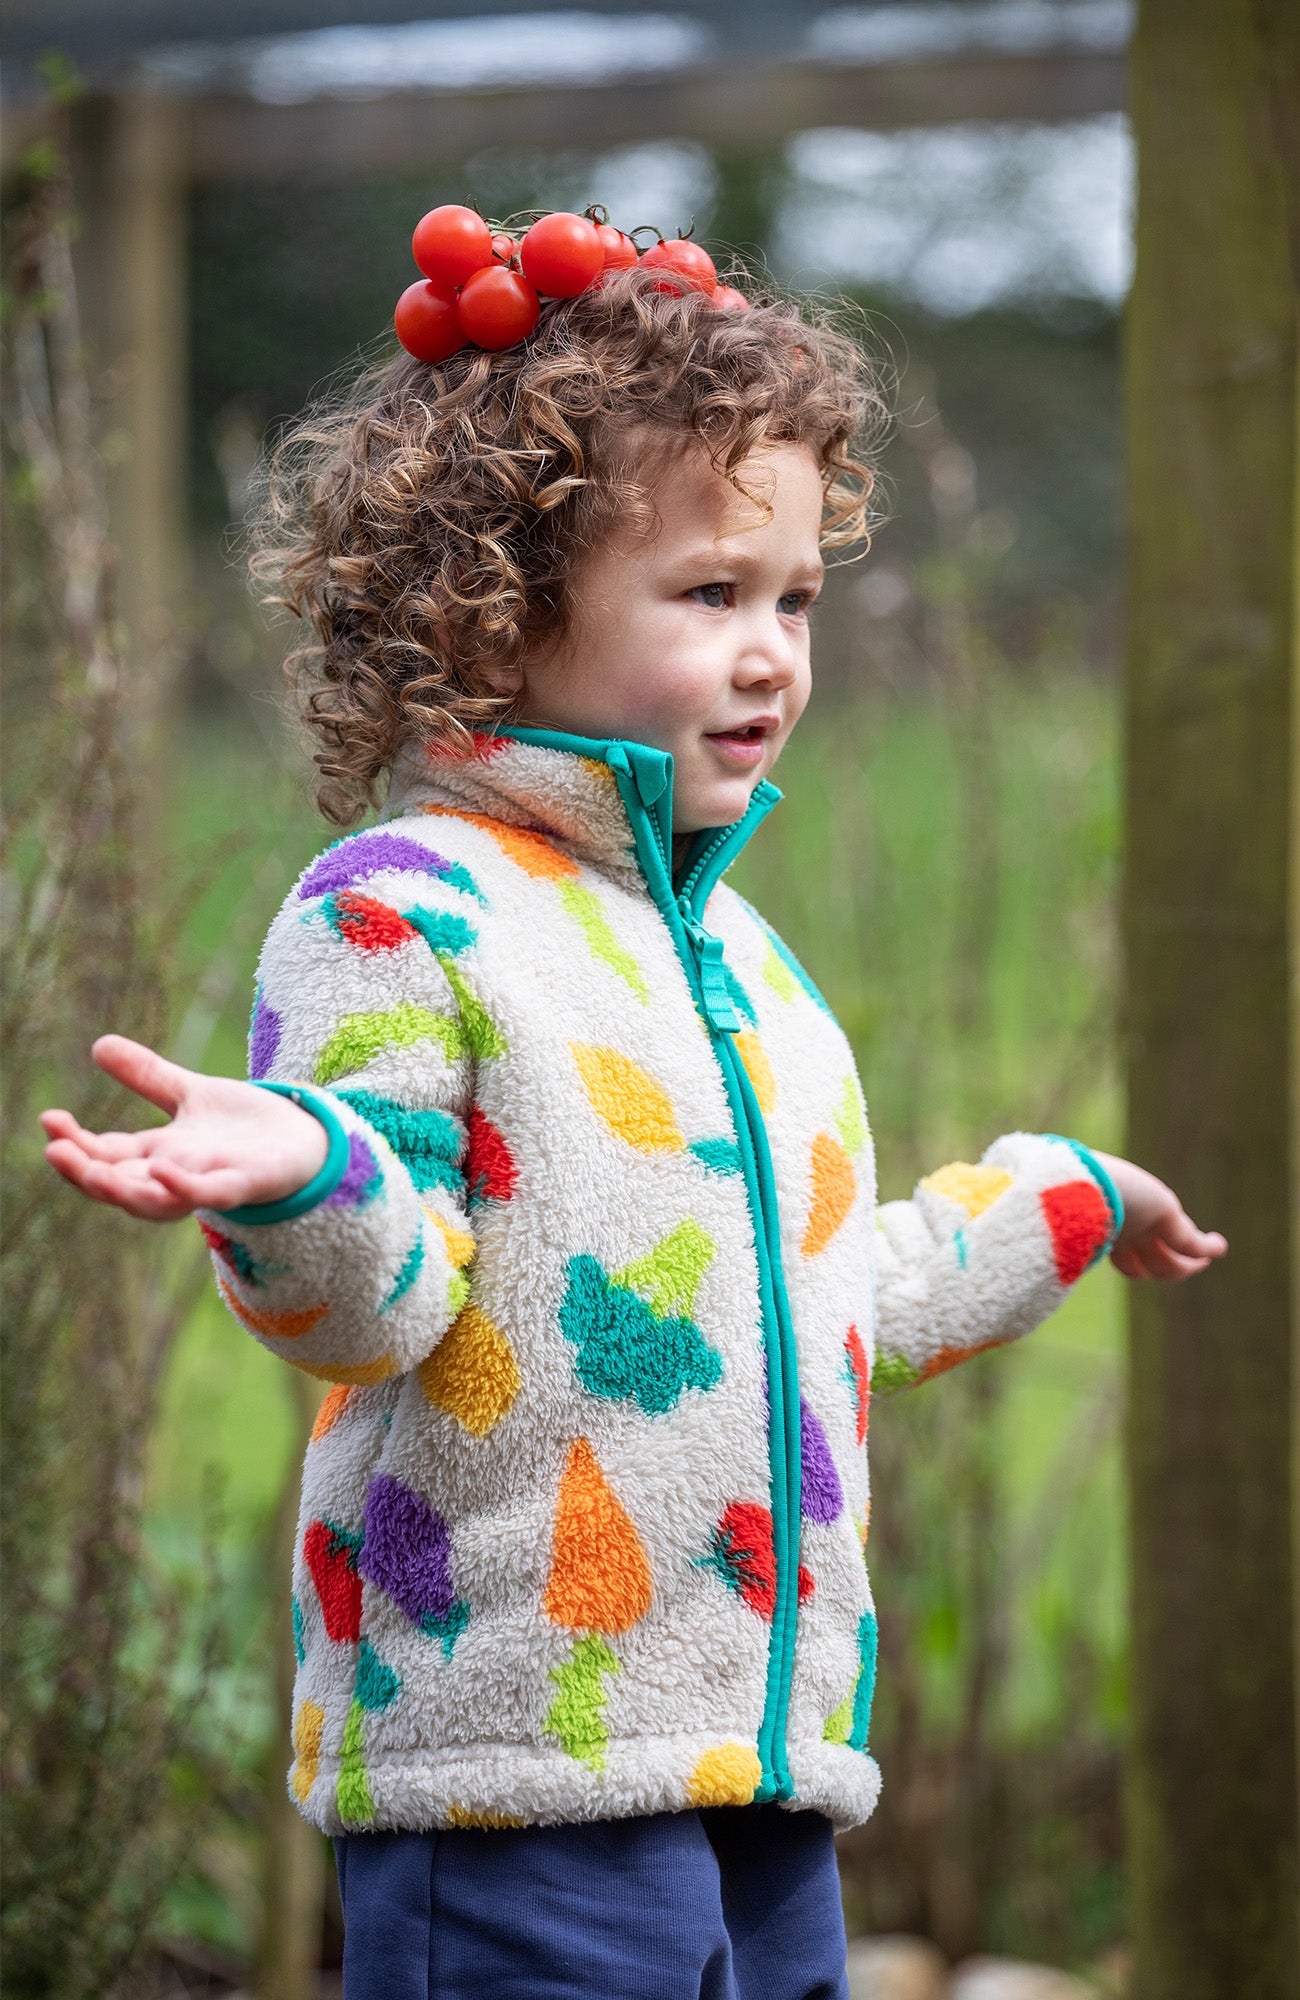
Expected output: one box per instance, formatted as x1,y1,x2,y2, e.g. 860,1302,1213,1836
384,728,780,908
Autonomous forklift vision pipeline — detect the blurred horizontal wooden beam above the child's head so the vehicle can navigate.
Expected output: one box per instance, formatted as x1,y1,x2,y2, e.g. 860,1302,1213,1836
188,50,1124,180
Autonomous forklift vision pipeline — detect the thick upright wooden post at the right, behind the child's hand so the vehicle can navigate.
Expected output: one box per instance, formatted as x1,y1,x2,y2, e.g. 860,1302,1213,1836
1124,0,1300,2000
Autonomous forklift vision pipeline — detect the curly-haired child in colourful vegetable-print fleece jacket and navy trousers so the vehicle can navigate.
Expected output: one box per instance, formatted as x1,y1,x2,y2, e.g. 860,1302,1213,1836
44,230,1226,2000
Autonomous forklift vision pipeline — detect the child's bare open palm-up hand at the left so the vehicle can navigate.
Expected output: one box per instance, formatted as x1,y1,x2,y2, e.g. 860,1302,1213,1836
40,1034,328,1222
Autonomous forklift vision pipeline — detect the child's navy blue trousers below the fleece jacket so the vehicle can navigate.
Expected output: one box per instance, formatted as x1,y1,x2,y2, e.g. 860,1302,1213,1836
334,1806,848,2000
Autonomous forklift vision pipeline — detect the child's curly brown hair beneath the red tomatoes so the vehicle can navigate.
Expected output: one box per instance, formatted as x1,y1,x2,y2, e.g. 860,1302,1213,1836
252,270,886,826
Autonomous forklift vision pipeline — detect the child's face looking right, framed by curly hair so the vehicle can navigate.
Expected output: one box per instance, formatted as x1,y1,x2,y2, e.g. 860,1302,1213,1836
508,444,824,834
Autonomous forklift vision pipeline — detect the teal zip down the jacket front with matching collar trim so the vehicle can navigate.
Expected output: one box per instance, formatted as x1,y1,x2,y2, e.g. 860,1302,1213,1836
498,728,800,1806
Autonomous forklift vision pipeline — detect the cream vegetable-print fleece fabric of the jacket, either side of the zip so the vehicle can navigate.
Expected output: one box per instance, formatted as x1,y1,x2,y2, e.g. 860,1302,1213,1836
200,738,1118,1832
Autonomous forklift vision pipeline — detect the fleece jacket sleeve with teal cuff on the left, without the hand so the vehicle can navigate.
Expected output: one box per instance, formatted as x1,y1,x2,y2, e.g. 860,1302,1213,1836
198,842,494,1384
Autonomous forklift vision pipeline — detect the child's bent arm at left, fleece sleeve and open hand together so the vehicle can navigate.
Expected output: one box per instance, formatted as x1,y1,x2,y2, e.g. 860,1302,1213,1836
42,876,484,1382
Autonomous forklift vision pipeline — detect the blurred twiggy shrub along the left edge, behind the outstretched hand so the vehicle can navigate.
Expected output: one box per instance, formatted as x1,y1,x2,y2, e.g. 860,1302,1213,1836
0,145,230,2000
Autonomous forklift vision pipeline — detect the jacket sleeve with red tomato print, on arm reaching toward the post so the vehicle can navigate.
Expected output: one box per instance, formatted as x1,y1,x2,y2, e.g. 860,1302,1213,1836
872,1132,1124,1390
